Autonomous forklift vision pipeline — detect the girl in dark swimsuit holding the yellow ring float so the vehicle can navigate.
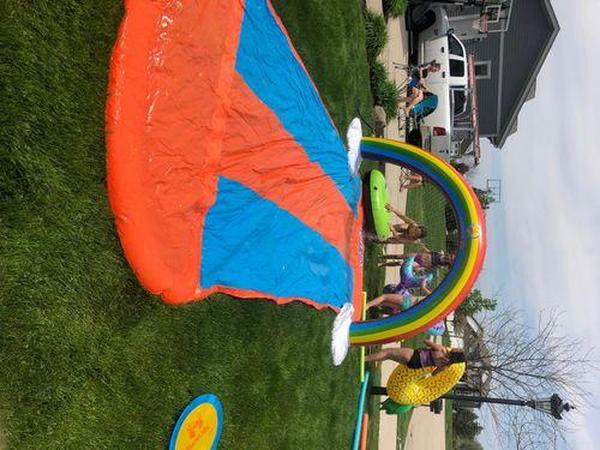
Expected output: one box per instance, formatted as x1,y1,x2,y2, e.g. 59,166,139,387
365,340,465,372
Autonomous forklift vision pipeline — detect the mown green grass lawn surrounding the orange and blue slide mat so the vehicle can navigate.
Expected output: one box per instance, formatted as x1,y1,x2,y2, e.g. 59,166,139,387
0,0,372,449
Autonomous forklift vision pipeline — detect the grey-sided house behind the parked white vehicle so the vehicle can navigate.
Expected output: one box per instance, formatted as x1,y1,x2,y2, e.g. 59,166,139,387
447,0,560,151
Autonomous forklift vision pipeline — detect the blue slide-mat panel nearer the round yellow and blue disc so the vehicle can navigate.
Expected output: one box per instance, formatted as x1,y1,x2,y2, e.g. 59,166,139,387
200,177,353,307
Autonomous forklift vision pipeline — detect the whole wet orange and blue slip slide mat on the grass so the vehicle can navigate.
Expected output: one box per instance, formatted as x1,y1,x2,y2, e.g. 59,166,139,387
107,0,362,308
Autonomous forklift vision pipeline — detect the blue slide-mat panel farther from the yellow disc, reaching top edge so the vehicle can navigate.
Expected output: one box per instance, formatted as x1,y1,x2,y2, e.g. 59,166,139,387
236,0,360,213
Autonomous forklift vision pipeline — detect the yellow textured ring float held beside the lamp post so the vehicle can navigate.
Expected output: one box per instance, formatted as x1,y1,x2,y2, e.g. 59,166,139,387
387,363,466,405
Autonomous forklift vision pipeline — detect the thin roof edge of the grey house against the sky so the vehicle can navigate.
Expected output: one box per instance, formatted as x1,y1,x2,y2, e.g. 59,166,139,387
493,0,560,147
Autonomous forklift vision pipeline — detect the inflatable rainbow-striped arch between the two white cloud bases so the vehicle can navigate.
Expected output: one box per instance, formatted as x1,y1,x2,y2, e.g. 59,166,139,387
350,138,486,345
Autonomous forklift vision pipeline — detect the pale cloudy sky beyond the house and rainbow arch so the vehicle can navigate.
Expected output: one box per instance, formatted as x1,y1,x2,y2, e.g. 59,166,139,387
470,0,600,449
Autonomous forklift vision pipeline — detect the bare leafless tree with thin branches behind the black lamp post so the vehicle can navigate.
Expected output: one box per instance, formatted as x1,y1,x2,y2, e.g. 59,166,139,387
467,307,594,450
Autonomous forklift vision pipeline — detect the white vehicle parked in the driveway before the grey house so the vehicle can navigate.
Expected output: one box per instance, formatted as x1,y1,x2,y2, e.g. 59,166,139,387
417,6,469,160
